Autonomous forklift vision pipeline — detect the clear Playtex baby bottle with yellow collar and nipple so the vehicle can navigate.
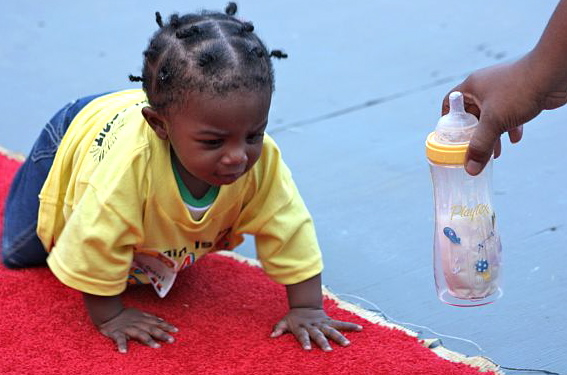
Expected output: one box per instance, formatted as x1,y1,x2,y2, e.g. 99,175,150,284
426,92,502,306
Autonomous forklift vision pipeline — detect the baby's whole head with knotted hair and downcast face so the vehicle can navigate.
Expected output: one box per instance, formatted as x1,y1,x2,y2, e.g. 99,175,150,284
134,3,286,192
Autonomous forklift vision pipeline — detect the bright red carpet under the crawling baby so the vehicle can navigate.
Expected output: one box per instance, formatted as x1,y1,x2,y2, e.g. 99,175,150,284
0,151,500,375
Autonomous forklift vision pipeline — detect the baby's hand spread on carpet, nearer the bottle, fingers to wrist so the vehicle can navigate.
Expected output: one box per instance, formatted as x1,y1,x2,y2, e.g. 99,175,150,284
271,308,362,352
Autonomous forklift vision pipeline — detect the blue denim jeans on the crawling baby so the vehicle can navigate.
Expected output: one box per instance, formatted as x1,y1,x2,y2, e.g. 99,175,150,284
2,95,106,268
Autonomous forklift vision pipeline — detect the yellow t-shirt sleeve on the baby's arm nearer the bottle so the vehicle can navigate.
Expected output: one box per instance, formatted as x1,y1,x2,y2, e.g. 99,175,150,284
237,138,323,285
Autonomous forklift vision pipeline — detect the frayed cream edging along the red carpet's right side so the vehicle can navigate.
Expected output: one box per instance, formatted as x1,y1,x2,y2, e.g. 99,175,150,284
223,251,505,375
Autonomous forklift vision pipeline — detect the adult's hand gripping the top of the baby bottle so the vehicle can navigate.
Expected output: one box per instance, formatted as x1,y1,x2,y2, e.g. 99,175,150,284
443,54,567,175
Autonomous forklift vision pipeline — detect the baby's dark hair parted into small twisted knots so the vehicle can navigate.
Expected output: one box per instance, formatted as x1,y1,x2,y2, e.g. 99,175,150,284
130,2,287,110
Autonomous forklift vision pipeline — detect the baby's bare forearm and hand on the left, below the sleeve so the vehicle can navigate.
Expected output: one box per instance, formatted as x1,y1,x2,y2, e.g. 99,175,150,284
83,293,177,353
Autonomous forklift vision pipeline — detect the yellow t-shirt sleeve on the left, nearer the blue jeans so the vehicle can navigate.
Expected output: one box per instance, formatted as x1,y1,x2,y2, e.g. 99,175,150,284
47,156,148,296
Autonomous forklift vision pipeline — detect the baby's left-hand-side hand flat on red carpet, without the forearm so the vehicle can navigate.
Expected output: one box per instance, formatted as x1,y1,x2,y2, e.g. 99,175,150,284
98,309,177,353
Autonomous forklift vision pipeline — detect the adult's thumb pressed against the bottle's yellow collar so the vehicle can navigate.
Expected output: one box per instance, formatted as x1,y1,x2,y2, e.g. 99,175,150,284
465,113,500,176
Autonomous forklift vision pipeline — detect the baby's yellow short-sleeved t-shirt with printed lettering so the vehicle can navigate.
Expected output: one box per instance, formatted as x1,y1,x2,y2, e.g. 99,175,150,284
37,90,323,296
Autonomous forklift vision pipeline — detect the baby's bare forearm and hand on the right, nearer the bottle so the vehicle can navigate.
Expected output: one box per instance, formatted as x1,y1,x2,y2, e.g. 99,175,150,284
271,274,362,351
